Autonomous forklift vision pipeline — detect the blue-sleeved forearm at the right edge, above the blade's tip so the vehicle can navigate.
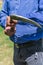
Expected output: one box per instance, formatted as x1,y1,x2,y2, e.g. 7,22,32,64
30,12,43,25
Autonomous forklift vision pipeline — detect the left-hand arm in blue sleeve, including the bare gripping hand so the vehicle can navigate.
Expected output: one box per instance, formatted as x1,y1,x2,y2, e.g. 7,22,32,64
0,0,17,36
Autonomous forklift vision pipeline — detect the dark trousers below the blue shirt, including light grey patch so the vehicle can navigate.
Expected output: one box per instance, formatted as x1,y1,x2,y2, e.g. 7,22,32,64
13,39,43,65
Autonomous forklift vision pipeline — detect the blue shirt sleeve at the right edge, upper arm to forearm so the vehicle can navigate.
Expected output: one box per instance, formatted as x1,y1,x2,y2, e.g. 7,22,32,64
30,0,43,25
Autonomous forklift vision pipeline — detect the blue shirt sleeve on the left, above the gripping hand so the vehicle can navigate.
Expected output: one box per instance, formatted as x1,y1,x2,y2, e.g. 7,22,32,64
0,0,8,28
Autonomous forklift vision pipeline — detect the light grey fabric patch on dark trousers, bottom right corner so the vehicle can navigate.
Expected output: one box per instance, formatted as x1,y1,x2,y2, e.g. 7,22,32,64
25,52,43,65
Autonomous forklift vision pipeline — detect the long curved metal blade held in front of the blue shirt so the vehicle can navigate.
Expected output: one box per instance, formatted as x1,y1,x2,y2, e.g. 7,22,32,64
10,15,42,28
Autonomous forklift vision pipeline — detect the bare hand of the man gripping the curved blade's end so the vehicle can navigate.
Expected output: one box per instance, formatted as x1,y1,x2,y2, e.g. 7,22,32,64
4,16,17,36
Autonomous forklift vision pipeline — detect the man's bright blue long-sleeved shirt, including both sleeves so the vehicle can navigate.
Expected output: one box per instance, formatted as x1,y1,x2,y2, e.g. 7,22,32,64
0,0,43,44
